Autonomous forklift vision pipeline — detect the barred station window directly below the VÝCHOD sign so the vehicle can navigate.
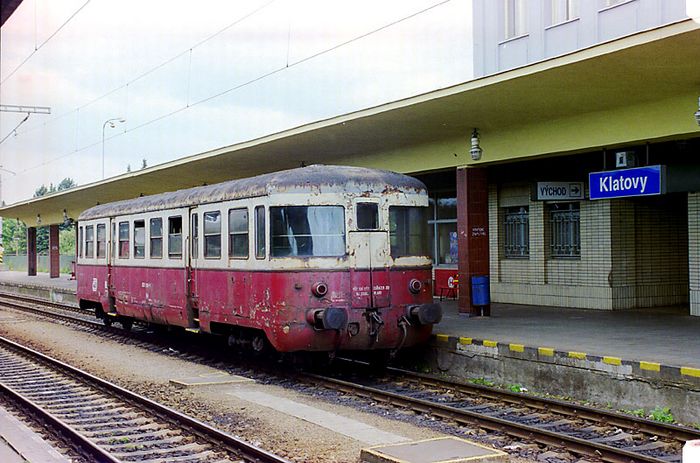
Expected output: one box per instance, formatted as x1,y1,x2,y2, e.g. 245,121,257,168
549,203,581,259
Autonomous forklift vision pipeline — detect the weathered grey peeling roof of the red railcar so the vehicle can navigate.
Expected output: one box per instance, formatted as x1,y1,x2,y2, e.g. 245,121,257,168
78,165,426,221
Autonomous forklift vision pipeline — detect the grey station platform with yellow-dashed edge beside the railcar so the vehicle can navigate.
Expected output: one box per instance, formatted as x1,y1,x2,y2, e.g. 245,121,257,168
0,271,700,423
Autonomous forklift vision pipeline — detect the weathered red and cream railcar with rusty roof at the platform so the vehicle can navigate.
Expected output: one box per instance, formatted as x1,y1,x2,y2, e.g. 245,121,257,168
77,166,441,352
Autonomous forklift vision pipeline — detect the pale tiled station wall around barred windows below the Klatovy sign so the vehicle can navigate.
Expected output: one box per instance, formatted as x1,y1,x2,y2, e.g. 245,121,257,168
489,184,700,310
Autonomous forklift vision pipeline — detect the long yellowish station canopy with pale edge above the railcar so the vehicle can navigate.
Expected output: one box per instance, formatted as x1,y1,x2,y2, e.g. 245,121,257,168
0,20,700,226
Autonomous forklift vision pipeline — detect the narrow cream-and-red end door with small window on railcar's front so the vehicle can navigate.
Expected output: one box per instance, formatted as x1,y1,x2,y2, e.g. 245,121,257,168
348,198,391,309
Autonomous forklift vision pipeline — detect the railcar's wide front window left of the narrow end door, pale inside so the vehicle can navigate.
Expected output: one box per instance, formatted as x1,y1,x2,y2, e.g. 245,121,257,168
270,206,345,257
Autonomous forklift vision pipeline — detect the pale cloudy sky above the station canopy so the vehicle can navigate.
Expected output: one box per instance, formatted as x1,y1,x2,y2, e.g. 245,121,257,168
0,0,473,204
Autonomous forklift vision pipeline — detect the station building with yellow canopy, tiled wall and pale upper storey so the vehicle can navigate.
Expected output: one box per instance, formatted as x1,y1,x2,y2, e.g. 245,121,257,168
0,0,700,316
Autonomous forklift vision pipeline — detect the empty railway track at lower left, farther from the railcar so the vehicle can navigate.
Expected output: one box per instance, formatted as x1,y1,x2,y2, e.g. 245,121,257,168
0,337,287,463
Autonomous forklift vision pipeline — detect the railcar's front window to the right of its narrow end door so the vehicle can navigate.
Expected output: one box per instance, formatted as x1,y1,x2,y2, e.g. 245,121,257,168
389,206,430,257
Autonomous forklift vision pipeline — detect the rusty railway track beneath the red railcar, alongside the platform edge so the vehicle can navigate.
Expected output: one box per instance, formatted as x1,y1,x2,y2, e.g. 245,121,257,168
3,294,700,463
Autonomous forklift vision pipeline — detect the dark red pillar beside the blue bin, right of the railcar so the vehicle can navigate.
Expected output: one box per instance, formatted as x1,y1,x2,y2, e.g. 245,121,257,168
457,168,491,317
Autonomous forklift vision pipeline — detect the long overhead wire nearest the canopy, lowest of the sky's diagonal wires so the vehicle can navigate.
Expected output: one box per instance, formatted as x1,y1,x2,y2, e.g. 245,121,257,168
19,0,452,173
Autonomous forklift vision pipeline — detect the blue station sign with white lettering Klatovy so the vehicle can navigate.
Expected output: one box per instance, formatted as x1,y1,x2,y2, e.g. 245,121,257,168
588,166,666,199
